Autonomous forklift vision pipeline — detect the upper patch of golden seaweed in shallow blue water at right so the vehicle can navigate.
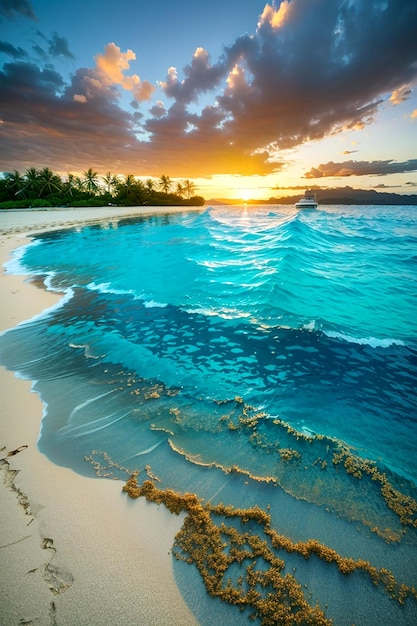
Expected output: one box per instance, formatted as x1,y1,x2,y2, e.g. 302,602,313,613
219,396,417,543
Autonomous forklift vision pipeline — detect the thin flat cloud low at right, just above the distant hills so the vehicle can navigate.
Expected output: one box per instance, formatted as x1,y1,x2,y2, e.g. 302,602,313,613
304,159,417,178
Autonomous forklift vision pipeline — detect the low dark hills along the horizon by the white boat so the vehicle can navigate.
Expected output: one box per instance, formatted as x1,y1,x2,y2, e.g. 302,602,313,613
206,187,417,206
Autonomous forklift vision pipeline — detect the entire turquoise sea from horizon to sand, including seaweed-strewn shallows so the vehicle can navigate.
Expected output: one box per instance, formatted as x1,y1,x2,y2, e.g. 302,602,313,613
0,205,417,626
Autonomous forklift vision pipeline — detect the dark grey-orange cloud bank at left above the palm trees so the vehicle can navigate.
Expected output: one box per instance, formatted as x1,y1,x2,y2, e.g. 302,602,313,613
0,58,134,161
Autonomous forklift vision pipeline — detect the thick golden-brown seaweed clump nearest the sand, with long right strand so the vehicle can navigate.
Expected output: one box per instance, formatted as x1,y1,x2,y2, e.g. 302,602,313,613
123,472,417,626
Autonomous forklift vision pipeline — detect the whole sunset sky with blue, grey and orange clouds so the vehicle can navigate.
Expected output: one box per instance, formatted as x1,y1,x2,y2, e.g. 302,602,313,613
0,0,417,200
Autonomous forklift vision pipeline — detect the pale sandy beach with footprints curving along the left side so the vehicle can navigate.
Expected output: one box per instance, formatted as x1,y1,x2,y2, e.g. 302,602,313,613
0,207,201,626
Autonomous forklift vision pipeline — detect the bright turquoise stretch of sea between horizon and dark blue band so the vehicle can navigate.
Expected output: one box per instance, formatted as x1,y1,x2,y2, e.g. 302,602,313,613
11,207,414,341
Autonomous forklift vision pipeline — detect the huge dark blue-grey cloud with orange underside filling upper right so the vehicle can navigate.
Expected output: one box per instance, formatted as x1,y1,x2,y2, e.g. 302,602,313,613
142,0,417,173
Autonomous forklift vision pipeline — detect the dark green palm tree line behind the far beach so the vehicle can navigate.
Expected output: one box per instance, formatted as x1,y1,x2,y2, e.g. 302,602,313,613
0,167,204,209
